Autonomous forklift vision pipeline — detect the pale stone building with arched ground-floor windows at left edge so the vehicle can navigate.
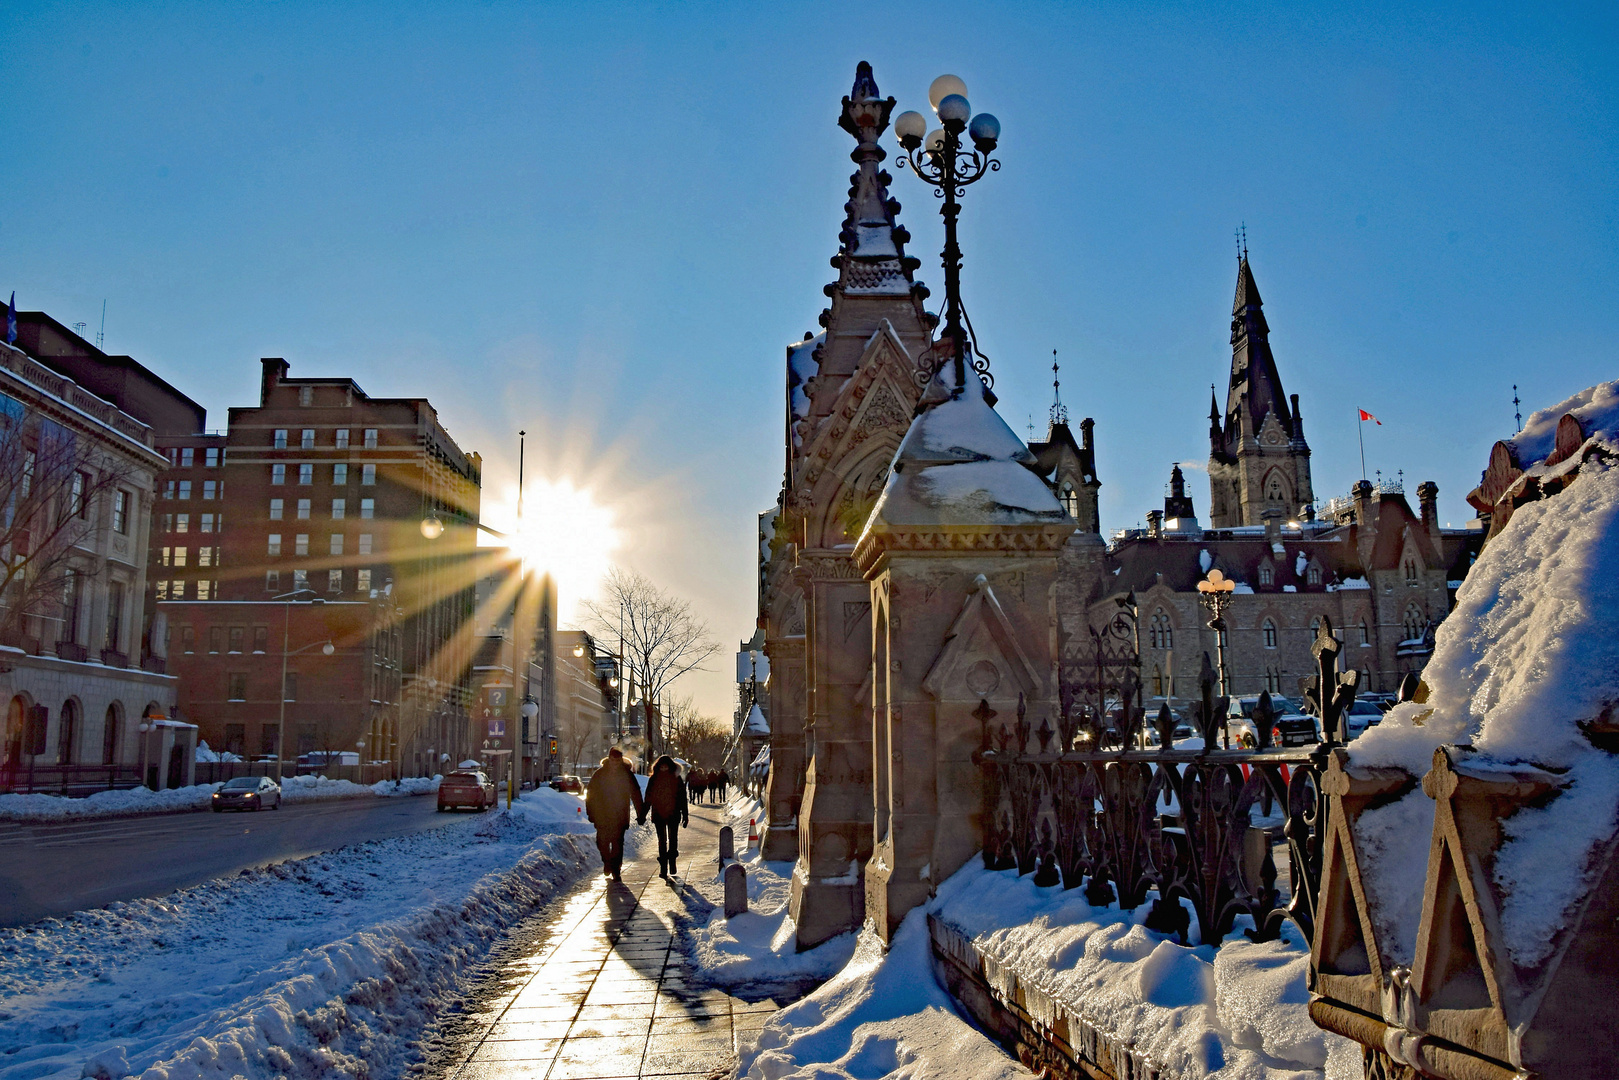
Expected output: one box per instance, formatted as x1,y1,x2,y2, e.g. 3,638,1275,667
0,345,178,793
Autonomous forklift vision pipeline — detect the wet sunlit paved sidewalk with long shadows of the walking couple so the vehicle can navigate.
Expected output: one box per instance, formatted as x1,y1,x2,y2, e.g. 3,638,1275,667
442,806,777,1080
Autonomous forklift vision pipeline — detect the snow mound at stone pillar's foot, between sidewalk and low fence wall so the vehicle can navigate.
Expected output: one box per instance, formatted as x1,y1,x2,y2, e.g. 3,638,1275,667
737,908,1030,1080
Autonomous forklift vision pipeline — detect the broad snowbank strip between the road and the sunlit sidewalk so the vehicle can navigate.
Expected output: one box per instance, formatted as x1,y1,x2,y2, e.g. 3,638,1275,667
0,789,599,1080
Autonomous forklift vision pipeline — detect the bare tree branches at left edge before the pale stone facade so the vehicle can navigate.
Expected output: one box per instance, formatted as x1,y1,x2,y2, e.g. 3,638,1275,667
0,395,136,640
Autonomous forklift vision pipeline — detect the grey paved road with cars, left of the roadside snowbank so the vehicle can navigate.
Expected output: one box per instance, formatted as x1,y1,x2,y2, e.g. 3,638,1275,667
0,797,473,926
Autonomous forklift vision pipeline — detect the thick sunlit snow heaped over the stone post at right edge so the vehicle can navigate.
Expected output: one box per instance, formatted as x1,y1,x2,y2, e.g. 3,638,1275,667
1352,440,1619,965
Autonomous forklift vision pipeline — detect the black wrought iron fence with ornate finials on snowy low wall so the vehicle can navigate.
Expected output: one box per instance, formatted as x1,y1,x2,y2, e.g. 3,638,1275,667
976,608,1357,944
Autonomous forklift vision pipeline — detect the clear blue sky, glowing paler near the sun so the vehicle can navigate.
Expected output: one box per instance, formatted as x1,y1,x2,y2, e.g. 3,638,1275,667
0,2,1619,709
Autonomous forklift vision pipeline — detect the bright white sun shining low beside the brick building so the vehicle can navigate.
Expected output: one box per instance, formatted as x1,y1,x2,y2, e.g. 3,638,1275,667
491,479,620,623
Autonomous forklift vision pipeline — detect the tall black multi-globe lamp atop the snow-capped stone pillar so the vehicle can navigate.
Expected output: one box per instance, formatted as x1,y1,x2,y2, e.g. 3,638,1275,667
894,74,1001,393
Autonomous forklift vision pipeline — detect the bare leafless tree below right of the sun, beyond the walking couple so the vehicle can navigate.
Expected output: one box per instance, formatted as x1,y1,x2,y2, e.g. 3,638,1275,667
584,567,719,753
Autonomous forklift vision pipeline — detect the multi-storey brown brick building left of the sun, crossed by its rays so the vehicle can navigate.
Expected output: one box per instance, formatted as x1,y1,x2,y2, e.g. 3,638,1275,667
160,358,482,774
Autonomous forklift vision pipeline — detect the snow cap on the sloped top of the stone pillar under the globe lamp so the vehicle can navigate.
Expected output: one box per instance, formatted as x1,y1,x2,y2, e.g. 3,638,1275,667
866,374,1067,529
